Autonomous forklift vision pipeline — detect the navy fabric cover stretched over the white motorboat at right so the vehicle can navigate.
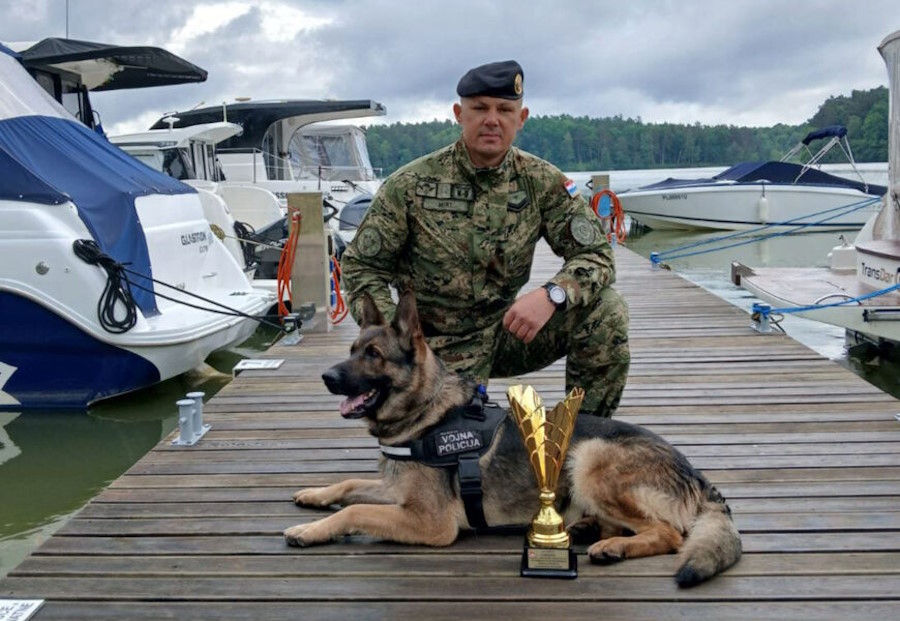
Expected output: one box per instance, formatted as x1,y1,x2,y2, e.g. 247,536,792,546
638,161,887,196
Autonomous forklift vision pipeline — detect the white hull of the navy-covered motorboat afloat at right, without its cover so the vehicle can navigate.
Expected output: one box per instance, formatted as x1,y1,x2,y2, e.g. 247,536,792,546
618,183,880,231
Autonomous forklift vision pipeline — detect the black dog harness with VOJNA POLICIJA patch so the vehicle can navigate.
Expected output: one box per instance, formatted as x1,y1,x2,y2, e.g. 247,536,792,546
381,391,506,528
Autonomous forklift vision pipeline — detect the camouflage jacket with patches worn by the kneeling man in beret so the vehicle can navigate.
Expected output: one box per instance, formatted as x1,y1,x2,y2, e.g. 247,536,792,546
341,139,615,336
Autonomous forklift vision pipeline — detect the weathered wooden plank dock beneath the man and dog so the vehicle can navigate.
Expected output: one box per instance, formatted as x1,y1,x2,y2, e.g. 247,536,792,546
0,248,900,621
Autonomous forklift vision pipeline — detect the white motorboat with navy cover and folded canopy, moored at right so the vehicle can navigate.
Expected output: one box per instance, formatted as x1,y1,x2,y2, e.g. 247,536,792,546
618,126,887,231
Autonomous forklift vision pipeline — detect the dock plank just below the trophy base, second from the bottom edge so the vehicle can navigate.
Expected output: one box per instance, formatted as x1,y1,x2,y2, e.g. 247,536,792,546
5,563,900,604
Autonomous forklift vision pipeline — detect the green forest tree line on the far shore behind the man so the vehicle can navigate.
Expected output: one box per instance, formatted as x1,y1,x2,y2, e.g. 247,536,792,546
367,86,889,175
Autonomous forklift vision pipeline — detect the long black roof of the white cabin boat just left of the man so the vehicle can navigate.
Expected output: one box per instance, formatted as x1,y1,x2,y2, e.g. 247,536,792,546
150,99,387,149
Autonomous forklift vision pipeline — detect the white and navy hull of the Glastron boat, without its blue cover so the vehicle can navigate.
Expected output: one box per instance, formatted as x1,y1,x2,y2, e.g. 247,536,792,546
0,194,275,409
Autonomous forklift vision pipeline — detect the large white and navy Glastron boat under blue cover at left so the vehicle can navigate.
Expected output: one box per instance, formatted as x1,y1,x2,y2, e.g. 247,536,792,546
0,46,274,409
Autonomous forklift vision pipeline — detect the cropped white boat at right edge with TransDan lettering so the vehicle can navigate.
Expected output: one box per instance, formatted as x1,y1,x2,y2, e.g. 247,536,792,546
732,31,900,343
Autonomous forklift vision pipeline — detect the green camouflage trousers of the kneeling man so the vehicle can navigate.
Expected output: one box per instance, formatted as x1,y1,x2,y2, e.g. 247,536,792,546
428,287,631,417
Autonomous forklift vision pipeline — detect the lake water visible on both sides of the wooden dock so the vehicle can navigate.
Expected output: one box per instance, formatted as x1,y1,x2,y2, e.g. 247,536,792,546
0,164,900,576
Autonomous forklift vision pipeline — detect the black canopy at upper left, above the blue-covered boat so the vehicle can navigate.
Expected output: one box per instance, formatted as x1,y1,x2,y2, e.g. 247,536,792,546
18,38,206,91
